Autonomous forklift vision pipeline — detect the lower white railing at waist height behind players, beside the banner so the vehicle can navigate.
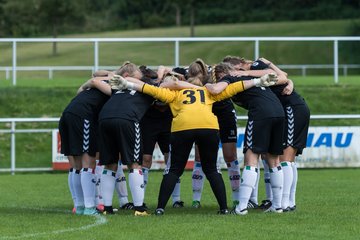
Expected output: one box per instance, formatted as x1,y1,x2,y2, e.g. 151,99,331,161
0,114,360,174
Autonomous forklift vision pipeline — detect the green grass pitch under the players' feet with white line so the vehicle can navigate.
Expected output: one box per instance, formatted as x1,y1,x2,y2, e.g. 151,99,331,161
0,169,360,240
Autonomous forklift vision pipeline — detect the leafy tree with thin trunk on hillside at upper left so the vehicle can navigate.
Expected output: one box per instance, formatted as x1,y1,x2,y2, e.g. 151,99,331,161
37,0,85,55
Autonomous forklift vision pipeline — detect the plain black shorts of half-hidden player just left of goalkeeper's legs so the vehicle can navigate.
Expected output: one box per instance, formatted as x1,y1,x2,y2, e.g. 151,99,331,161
141,117,172,155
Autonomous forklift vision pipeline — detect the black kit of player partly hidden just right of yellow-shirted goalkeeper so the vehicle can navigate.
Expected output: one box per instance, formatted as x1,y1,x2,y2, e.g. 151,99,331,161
213,101,237,143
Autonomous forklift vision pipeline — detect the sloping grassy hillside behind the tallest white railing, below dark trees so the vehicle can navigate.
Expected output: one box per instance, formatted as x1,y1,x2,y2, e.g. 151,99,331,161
0,19,359,66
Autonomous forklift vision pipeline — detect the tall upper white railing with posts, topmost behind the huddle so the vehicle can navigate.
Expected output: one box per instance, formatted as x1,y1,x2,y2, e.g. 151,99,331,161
0,37,360,85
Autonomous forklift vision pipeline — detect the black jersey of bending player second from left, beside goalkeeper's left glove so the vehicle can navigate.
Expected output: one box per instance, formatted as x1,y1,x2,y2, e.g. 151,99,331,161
99,89,154,122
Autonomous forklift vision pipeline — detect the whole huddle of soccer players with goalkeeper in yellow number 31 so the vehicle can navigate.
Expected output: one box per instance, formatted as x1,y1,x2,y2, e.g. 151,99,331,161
59,56,310,216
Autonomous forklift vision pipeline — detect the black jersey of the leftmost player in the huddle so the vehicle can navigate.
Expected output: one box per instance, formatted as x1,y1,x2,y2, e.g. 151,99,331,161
64,88,109,120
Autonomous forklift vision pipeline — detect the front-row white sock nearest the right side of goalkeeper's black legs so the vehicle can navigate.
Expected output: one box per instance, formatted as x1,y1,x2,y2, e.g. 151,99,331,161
236,166,258,211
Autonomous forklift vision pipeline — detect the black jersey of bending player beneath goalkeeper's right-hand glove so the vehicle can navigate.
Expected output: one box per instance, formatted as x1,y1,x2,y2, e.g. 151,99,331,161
220,75,285,120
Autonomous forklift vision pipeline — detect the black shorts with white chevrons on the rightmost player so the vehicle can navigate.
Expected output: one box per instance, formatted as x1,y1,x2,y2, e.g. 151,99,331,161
284,104,310,155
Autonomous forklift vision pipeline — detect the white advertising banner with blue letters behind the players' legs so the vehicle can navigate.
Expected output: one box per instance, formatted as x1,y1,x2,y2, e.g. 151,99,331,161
52,127,360,170
